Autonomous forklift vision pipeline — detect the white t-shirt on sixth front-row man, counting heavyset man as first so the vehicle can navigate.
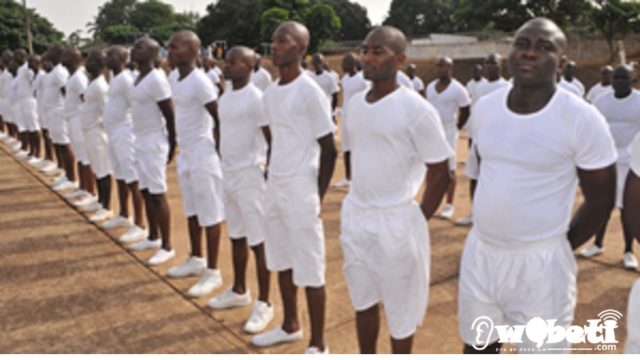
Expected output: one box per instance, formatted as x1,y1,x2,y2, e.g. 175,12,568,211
131,69,171,137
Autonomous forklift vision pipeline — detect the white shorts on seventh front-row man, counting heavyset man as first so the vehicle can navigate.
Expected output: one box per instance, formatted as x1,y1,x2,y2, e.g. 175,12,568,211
107,127,138,184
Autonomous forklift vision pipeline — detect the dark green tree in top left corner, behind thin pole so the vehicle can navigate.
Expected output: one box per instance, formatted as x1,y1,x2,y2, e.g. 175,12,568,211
0,0,64,53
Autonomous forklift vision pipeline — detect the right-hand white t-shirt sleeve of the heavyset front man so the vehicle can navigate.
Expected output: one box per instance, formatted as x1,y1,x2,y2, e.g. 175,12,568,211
574,105,618,170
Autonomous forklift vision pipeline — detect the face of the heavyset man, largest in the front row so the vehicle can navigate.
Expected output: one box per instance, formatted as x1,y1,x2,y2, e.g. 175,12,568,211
509,24,562,84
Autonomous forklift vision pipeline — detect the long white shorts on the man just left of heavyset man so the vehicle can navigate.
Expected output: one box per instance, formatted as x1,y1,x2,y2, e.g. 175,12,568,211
340,198,431,339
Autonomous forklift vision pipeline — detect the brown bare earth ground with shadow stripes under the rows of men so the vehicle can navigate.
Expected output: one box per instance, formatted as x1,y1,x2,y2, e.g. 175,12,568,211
0,131,638,353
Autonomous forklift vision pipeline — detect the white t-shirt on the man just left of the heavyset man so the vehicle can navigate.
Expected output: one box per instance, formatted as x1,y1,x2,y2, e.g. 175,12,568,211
343,86,453,207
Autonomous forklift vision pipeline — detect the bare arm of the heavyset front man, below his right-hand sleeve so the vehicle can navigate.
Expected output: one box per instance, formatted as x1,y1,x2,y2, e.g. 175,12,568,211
567,164,616,249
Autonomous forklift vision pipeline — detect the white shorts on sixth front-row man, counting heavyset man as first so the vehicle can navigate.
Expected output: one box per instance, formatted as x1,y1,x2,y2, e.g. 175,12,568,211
134,133,169,195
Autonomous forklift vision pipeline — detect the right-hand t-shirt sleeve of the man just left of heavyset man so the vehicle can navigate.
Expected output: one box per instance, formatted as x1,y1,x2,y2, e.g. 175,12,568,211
410,104,454,164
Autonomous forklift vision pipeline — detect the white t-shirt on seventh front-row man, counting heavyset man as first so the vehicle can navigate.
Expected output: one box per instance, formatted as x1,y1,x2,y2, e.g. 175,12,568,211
104,71,133,130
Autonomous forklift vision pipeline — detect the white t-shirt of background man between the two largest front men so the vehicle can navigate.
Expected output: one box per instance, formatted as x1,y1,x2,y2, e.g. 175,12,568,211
427,79,471,135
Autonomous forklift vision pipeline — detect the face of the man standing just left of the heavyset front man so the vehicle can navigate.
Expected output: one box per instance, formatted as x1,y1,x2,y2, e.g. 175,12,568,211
362,32,404,82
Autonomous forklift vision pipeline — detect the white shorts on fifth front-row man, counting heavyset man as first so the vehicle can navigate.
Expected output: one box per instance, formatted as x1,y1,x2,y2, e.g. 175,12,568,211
177,150,224,227
